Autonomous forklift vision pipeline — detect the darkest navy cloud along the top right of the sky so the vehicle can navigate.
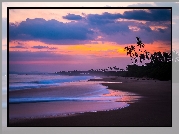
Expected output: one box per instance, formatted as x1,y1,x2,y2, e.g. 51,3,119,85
87,9,171,25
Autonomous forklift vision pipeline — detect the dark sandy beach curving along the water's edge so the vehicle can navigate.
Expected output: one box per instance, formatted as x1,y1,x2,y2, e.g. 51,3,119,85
9,77,172,127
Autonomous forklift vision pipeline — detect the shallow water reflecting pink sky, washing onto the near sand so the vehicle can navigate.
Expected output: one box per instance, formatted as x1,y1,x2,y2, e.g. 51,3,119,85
9,81,139,119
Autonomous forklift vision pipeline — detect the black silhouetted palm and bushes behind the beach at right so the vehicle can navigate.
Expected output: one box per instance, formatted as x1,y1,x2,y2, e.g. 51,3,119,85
124,37,171,80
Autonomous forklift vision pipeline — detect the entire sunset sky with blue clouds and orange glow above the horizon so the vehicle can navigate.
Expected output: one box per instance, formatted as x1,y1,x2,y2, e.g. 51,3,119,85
9,9,171,72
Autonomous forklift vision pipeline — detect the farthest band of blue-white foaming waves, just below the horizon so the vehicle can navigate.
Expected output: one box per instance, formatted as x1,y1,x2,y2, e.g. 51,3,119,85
9,74,93,91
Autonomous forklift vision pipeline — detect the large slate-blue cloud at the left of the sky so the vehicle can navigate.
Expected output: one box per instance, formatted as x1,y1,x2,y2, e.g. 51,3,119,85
9,18,93,41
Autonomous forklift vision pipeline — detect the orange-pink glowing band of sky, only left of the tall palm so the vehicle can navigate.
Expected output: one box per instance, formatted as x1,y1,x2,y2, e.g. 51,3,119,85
9,41,125,57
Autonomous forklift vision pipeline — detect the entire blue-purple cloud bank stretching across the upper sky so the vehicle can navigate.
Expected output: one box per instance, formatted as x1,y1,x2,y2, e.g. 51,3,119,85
9,9,171,45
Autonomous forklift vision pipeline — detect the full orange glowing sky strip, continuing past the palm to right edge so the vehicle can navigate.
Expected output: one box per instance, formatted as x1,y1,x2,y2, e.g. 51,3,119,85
9,41,171,58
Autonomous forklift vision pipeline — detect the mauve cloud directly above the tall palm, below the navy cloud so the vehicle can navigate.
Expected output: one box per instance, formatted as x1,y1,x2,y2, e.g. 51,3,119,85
102,24,171,45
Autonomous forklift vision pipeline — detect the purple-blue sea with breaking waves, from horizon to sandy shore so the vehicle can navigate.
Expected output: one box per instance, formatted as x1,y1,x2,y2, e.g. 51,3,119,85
7,74,136,119
